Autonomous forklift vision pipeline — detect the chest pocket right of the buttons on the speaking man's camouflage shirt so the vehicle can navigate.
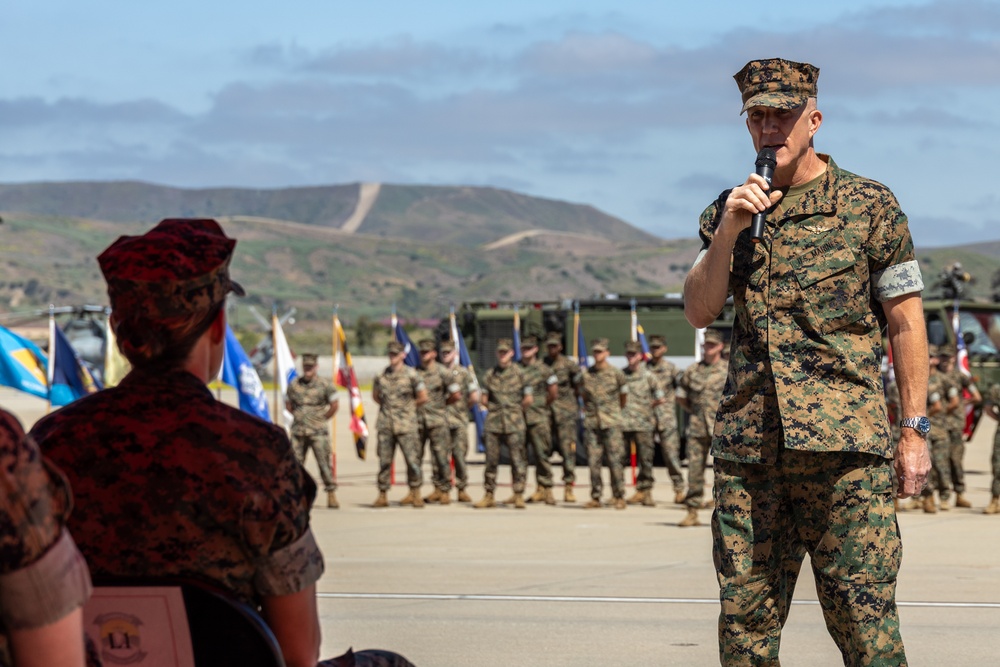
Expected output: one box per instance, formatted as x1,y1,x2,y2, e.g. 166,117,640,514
791,232,868,334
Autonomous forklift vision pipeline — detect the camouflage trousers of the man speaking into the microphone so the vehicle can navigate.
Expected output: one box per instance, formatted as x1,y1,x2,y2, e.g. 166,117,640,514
712,450,906,667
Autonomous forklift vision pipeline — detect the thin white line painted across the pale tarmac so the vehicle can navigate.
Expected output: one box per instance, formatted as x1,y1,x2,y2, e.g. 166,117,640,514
316,593,1000,609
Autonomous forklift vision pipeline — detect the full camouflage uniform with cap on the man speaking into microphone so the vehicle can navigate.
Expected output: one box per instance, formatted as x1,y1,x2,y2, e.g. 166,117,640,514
700,60,923,665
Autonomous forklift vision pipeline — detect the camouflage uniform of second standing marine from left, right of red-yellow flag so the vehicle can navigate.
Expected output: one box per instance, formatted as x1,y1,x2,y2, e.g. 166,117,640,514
372,366,425,493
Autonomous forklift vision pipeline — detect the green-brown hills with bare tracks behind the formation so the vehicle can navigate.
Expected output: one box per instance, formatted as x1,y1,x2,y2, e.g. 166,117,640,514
0,183,1000,344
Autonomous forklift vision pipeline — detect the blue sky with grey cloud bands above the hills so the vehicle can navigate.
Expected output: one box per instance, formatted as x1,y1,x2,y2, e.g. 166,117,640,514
0,0,1000,247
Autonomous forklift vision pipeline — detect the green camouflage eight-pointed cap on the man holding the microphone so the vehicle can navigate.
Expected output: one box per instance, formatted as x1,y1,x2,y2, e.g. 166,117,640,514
733,58,819,115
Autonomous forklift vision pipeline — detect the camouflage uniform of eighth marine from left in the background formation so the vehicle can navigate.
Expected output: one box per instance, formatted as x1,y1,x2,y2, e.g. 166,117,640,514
580,354,628,500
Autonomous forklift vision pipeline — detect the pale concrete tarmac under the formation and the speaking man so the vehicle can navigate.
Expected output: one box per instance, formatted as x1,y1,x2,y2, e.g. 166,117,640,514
0,388,1000,667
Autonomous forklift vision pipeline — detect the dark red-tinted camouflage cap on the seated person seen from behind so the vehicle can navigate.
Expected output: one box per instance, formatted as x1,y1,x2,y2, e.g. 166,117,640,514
97,218,246,320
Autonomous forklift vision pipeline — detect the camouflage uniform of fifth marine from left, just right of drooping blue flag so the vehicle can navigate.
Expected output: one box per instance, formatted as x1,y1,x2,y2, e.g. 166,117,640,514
482,364,532,494
